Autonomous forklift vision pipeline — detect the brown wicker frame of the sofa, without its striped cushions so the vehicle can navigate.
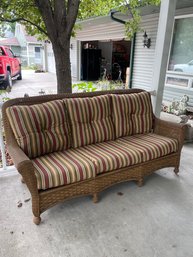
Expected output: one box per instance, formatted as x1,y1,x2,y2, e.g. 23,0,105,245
2,89,185,224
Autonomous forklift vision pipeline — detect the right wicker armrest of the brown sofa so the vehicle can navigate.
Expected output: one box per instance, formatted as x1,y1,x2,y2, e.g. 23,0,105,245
153,117,187,147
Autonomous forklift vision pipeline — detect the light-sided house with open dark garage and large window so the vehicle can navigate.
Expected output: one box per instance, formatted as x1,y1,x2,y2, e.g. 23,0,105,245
44,0,193,105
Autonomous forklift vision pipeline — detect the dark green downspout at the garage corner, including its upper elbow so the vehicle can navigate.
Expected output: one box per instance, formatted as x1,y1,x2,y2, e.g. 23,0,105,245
110,11,136,88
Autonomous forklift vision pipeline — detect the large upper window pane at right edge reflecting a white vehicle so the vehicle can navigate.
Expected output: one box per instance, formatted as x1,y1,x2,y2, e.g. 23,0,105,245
168,17,193,73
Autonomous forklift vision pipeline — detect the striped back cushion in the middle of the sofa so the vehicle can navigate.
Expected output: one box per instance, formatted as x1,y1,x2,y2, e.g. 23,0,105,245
65,95,114,148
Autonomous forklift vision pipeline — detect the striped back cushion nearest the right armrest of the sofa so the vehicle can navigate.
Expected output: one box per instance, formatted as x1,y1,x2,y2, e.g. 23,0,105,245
112,92,153,138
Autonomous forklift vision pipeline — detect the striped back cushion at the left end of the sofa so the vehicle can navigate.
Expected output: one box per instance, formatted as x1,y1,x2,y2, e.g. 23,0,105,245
7,100,70,158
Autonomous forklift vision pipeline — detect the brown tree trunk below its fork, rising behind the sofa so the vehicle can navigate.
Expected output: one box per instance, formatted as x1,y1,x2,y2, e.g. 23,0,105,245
52,39,72,94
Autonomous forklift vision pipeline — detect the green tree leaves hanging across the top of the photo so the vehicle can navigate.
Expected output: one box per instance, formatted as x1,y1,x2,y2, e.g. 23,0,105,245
0,0,161,39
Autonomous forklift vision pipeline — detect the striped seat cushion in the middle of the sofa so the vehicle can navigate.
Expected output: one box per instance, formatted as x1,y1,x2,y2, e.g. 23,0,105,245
76,141,142,174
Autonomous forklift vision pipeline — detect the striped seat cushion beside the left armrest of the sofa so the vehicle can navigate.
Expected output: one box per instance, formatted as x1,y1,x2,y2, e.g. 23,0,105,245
32,149,97,189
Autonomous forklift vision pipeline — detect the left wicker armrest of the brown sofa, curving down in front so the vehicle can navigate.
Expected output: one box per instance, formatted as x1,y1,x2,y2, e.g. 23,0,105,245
8,142,38,195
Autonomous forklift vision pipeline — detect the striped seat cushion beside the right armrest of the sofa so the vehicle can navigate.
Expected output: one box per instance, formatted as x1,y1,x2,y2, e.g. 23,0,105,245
117,133,178,162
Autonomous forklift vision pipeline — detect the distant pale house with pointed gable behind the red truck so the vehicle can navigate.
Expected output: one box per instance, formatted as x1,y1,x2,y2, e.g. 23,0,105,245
0,23,44,68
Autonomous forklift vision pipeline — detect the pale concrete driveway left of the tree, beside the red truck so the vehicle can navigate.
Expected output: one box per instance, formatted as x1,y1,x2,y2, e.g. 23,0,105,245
8,70,57,98
